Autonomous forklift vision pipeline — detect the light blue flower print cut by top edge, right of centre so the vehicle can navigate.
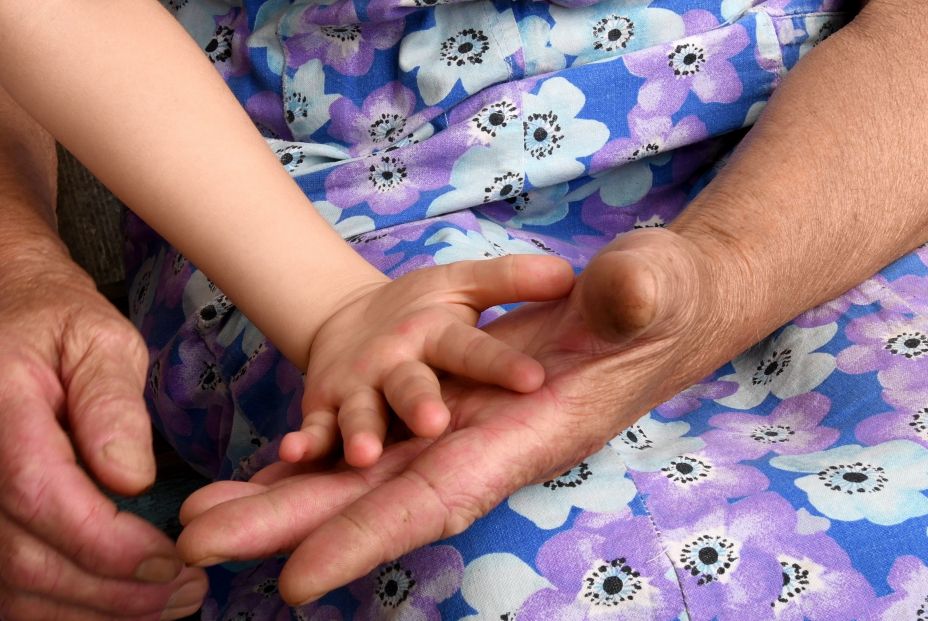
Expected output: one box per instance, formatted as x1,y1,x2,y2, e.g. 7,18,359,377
550,0,685,65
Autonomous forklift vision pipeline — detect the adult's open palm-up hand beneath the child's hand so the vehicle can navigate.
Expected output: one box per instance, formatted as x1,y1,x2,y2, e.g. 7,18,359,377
178,225,741,603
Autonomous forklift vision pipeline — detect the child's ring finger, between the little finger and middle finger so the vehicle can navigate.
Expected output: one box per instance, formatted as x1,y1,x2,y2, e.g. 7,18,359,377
338,388,389,468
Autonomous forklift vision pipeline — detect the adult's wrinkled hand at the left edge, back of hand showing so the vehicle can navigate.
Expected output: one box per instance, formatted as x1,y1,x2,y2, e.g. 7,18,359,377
0,249,206,621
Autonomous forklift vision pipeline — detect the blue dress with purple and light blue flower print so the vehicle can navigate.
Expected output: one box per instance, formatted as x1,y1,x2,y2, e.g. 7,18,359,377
127,0,928,621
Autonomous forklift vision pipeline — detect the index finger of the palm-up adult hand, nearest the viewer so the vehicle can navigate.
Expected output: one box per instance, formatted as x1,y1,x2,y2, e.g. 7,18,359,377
279,414,550,604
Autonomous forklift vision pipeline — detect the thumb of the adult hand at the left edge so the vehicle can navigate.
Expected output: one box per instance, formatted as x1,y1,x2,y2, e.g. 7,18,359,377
61,319,155,494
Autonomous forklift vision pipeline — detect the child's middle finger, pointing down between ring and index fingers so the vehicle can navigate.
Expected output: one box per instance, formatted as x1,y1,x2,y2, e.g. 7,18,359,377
383,360,451,438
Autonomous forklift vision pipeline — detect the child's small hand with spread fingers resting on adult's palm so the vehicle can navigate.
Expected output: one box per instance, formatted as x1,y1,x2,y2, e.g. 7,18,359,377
280,255,574,467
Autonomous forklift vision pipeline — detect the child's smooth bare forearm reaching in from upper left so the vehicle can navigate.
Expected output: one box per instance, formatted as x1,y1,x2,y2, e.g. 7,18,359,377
0,0,386,366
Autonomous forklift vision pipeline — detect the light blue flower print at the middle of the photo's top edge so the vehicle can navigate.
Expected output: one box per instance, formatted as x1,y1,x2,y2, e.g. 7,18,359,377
399,2,520,106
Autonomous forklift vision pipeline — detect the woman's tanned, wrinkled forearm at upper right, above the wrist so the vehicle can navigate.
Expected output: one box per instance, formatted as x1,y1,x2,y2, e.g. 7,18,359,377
673,0,928,346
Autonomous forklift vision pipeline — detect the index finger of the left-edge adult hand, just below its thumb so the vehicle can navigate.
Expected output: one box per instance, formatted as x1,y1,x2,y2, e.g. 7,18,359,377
0,360,182,582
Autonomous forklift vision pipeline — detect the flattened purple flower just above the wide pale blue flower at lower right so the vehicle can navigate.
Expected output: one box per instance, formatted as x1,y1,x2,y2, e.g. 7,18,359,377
702,392,841,459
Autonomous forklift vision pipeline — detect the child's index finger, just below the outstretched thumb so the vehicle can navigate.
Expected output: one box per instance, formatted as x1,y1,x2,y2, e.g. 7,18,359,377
425,323,545,393
